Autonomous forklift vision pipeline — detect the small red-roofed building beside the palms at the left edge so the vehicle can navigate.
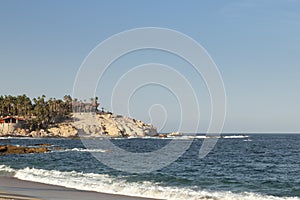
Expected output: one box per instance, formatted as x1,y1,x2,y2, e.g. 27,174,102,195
0,116,25,134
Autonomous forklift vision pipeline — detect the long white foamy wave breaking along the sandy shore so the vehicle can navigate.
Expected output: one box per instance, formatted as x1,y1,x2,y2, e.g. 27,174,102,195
0,165,300,200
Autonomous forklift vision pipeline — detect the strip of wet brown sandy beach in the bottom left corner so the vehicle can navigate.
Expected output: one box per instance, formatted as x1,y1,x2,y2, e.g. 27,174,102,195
0,176,161,200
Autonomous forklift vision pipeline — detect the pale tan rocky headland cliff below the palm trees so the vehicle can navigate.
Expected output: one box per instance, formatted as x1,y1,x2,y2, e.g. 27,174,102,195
0,113,157,137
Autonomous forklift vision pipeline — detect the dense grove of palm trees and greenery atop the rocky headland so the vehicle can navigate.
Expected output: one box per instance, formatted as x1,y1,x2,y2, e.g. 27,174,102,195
0,94,99,130
